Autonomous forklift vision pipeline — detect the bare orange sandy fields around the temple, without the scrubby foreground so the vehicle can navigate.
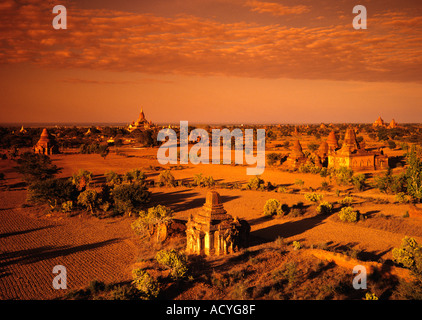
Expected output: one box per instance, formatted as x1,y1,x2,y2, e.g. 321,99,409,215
0,149,422,299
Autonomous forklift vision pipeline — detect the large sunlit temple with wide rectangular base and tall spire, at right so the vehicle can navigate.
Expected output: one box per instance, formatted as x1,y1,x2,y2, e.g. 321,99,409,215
327,128,388,171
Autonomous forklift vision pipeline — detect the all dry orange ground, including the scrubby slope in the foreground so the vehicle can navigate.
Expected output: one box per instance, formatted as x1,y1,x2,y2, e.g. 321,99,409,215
0,143,422,299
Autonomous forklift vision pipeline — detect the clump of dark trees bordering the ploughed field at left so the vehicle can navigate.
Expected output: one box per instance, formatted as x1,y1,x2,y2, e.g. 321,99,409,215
16,153,151,216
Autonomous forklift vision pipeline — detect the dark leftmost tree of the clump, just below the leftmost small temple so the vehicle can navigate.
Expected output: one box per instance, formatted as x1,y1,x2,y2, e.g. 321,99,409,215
15,152,61,183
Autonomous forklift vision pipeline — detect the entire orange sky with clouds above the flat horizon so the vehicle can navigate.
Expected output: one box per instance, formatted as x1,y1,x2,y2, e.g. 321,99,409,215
0,0,422,124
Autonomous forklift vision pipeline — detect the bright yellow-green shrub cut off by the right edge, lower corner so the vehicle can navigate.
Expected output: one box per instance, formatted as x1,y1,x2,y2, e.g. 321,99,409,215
392,237,422,278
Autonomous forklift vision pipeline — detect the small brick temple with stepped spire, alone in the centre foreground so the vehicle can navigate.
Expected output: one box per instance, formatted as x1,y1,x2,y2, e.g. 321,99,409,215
186,191,250,256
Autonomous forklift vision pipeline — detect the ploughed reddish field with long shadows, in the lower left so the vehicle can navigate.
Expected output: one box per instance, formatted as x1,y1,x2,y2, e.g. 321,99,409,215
0,191,135,299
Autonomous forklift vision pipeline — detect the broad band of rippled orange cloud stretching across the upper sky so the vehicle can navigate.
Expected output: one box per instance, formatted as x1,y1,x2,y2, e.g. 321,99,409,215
0,0,422,84
